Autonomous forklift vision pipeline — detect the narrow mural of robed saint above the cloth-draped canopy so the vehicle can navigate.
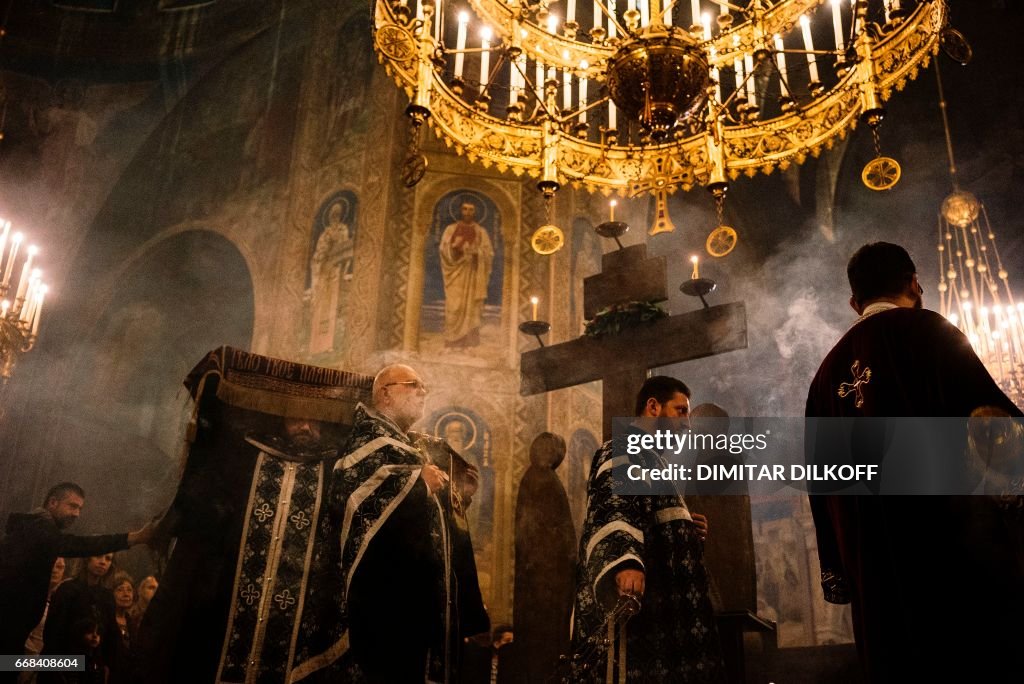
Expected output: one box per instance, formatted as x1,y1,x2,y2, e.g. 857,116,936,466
307,190,356,354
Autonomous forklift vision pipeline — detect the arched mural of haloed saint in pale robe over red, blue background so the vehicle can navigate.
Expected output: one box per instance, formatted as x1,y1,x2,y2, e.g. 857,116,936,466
422,190,502,350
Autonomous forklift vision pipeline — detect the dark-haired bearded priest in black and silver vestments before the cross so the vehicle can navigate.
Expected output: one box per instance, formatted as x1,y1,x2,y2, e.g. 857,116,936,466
571,376,725,684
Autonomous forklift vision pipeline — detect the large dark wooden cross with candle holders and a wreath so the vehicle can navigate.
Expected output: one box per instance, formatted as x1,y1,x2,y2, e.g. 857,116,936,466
519,245,746,439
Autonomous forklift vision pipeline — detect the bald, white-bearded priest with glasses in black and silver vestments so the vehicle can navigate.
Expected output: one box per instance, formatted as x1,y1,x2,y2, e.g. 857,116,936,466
289,365,487,683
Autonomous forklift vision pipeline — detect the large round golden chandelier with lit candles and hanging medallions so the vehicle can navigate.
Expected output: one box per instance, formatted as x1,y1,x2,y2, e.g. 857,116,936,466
375,0,946,256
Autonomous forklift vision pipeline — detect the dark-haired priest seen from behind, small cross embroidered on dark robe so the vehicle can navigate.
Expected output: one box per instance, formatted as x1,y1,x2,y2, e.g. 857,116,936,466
807,243,1024,682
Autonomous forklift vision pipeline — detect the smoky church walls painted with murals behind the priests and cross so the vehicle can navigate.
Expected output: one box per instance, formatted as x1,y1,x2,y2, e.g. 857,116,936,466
0,0,1024,681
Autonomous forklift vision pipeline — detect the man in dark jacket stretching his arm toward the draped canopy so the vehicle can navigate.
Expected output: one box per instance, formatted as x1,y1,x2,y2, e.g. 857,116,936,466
0,482,154,671
